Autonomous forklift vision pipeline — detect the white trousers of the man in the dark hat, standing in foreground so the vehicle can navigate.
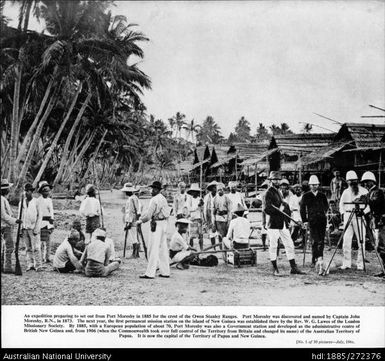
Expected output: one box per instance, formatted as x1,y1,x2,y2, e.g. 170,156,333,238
145,221,170,277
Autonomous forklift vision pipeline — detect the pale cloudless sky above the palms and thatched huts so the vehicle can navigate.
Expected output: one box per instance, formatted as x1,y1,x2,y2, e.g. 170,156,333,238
5,0,385,136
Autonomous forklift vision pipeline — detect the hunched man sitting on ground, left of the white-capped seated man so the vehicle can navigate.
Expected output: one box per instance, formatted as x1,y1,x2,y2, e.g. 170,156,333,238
53,229,82,273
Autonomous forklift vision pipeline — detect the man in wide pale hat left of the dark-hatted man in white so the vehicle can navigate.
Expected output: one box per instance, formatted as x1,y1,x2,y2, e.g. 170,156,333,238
121,183,141,258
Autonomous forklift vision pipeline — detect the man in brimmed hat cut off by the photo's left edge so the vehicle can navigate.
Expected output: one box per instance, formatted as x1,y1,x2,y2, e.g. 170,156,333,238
1,179,21,273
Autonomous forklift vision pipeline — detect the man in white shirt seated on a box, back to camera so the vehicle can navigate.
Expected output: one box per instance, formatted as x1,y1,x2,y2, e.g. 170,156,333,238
223,203,250,249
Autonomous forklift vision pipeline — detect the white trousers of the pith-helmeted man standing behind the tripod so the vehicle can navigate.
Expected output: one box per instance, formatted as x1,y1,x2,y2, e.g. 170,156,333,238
342,216,366,268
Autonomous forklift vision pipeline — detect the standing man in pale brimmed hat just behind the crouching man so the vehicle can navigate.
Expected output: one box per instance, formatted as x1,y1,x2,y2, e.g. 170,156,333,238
187,183,203,250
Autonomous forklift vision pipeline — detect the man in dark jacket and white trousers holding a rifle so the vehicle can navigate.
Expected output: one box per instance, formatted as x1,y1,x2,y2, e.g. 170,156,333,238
263,171,304,276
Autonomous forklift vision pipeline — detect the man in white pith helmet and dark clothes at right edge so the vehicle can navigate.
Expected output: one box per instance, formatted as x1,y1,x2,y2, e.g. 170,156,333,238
361,172,385,277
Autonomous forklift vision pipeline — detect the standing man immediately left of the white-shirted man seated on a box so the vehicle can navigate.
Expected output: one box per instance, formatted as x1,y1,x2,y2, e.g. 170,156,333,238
213,183,231,246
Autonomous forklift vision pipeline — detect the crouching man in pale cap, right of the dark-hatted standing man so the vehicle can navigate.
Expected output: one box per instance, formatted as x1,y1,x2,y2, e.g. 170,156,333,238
170,218,196,269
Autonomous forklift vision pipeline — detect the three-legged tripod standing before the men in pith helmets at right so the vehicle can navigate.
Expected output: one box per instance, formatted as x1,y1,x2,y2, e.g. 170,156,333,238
322,202,385,276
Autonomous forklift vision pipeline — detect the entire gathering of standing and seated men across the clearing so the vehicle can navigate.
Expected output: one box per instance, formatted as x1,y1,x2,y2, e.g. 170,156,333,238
1,167,385,279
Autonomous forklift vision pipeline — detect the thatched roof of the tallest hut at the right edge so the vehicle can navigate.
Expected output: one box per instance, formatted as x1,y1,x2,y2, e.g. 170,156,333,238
334,123,385,149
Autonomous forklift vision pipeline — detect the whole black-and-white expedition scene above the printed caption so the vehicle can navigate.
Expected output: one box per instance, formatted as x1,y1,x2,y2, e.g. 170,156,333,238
0,0,385,348
